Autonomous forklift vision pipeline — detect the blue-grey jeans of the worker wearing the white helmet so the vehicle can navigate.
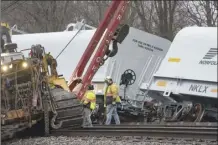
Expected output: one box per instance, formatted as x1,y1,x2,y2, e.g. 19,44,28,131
105,104,120,125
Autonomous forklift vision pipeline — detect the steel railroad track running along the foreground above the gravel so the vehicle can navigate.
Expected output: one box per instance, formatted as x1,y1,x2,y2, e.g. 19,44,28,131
51,124,218,140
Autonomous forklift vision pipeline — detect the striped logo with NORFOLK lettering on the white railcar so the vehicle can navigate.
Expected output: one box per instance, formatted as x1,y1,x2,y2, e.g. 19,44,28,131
199,48,217,65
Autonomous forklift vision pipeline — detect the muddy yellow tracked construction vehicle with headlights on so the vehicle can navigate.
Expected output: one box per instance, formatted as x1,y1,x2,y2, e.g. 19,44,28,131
1,22,83,140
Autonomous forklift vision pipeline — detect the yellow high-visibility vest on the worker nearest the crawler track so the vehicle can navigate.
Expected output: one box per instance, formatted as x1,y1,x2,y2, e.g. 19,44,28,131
83,90,96,110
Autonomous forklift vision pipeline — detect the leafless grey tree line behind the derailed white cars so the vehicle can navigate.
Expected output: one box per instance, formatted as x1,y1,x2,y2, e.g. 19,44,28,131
1,0,217,41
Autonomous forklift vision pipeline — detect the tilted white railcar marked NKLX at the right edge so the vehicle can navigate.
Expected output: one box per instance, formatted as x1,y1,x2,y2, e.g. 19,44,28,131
141,27,218,122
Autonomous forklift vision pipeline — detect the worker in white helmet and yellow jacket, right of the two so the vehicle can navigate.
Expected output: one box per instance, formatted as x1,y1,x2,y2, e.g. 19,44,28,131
104,76,120,125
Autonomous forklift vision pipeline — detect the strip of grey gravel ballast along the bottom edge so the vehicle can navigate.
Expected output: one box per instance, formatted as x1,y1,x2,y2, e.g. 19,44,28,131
2,136,217,145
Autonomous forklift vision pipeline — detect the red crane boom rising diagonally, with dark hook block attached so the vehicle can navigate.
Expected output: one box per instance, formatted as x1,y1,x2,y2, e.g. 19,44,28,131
68,0,129,99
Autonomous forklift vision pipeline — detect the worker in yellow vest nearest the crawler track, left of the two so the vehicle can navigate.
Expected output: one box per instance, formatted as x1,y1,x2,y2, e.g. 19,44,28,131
82,85,96,127
